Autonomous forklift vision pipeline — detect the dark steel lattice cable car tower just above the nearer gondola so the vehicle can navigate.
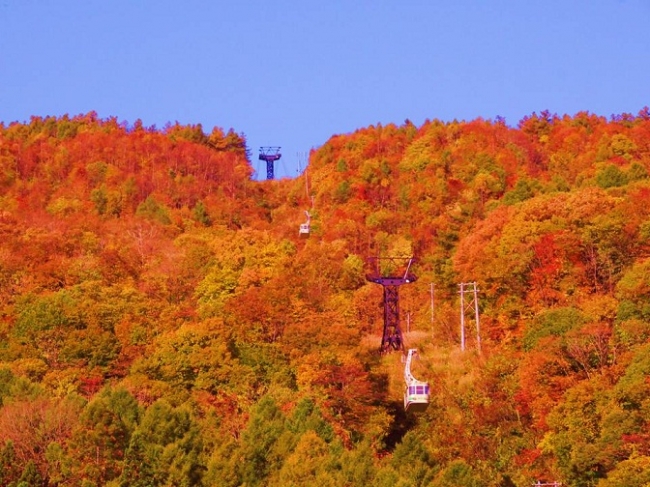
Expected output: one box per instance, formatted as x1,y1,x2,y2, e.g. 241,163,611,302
366,257,416,353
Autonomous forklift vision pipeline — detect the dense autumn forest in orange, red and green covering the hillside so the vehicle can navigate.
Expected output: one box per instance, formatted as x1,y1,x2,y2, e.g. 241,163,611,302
0,108,650,487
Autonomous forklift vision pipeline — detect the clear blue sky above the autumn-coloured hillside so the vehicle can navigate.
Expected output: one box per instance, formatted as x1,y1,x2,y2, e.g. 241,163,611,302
0,0,650,178
